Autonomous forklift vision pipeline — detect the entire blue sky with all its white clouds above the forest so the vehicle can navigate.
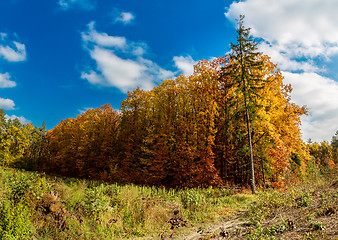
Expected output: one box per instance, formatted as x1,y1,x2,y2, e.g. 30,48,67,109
0,0,338,142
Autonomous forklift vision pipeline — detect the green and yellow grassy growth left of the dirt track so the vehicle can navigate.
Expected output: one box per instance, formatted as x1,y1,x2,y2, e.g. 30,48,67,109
0,169,253,240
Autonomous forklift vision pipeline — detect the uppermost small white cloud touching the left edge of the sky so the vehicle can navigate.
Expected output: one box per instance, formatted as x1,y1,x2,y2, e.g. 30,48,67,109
0,33,26,62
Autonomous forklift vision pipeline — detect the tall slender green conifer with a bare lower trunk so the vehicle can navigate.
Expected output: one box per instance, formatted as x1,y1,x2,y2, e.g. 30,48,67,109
226,15,265,194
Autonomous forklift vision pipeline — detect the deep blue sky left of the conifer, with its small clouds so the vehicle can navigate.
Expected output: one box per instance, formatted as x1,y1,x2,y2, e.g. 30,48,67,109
0,0,235,129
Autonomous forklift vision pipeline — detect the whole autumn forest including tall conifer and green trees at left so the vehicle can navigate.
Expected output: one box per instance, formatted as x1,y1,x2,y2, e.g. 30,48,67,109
0,19,338,191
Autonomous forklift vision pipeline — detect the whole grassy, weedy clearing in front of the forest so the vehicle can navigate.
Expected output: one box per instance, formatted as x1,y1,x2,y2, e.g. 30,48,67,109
0,169,338,240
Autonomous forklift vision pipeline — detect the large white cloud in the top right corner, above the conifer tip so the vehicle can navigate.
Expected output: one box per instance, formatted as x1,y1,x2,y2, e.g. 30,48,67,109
225,0,338,57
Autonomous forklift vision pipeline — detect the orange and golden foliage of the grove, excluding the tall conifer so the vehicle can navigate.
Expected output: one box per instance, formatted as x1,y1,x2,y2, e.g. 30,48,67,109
40,56,308,187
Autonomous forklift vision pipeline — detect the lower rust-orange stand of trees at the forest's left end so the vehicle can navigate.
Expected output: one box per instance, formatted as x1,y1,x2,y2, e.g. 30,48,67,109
40,104,120,180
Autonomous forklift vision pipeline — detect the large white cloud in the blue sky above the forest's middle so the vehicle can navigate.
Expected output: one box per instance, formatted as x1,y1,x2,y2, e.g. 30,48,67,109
81,23,174,92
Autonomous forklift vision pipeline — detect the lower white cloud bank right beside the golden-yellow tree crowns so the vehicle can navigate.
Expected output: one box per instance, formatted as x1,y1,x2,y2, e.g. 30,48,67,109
283,72,338,141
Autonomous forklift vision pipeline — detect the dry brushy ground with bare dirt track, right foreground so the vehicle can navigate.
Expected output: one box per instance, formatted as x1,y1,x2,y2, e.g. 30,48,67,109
172,174,338,240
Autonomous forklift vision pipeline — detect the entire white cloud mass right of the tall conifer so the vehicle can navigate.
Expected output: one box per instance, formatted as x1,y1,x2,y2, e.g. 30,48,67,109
225,0,338,141
